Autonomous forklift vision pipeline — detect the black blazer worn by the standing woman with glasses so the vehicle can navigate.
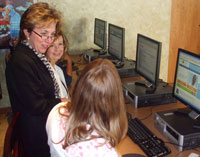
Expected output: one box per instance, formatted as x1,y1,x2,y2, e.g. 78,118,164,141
6,44,60,157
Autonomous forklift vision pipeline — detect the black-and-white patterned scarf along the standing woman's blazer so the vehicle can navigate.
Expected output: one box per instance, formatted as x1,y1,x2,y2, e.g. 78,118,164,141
21,40,61,98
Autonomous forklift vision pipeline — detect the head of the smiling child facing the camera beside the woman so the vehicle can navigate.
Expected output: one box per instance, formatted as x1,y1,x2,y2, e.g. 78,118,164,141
46,32,68,63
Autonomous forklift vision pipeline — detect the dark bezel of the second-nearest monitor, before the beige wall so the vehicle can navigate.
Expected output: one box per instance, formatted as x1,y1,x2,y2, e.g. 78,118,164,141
135,34,162,86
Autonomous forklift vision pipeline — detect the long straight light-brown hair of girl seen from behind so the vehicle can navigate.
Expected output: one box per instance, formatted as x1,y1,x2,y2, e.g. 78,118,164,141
60,59,128,148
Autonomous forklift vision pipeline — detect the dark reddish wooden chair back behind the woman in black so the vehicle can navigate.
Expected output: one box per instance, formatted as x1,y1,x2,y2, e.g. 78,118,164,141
3,112,23,157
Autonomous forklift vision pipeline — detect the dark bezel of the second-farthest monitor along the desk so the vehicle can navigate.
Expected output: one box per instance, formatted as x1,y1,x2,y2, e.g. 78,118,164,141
108,23,125,62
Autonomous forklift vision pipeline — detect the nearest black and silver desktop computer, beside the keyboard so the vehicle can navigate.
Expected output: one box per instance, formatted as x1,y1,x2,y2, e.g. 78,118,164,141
154,108,200,151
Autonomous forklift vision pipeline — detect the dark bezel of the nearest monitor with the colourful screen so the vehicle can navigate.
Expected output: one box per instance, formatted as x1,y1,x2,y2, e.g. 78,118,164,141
172,48,200,113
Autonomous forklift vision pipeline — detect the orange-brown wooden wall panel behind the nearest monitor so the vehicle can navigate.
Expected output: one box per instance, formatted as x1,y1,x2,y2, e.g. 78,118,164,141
168,0,200,83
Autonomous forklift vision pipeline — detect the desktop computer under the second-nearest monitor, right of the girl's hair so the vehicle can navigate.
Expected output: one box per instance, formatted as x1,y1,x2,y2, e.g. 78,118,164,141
122,80,177,108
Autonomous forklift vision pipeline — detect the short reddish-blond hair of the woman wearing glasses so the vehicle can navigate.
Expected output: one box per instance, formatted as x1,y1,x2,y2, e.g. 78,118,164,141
19,2,61,41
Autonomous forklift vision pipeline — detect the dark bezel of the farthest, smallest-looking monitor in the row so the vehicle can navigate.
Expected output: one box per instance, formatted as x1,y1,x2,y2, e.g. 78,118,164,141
94,18,107,50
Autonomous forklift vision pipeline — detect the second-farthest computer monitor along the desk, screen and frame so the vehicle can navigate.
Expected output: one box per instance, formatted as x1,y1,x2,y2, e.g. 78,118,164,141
108,24,125,61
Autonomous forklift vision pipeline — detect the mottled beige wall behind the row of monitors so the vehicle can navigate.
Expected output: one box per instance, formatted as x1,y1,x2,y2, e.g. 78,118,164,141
38,0,171,81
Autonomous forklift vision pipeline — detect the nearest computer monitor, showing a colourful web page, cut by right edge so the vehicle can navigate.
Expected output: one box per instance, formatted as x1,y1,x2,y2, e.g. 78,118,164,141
173,49,200,119
